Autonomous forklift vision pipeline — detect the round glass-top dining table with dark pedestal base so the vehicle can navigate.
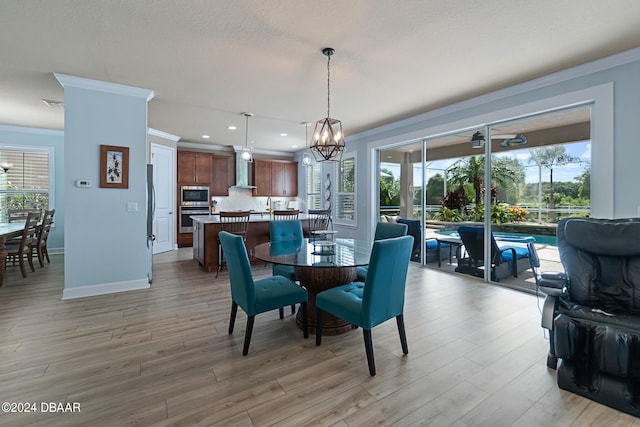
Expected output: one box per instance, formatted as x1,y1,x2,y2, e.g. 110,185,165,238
251,238,373,335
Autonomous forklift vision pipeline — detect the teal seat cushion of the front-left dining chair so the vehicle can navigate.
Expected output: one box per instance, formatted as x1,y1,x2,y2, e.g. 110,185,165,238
252,276,307,314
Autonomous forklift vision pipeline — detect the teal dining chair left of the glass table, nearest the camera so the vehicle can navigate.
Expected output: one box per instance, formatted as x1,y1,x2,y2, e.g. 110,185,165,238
218,231,309,356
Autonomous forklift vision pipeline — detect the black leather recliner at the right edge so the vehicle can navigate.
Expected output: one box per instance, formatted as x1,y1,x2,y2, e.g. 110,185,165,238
538,218,640,417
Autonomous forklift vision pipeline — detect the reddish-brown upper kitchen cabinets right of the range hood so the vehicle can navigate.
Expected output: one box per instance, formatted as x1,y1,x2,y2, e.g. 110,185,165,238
253,159,298,197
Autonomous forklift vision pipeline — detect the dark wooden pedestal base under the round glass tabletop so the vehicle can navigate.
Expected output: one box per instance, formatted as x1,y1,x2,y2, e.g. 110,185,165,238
295,266,356,335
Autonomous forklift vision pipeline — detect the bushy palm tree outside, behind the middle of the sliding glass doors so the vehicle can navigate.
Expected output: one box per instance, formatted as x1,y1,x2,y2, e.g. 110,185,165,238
449,156,523,205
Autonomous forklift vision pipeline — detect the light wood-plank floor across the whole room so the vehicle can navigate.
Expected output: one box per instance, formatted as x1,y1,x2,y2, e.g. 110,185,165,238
0,249,640,427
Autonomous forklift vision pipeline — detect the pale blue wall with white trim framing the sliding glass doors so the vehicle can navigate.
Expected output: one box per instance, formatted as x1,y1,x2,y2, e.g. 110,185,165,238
299,49,640,238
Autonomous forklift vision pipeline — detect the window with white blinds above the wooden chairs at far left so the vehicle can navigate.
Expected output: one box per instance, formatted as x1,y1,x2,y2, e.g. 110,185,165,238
0,149,50,221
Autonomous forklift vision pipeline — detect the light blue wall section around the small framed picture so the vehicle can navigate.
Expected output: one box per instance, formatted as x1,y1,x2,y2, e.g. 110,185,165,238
56,74,153,299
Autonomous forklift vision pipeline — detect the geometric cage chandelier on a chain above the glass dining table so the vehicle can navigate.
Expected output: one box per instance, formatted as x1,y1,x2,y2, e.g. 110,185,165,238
311,47,345,162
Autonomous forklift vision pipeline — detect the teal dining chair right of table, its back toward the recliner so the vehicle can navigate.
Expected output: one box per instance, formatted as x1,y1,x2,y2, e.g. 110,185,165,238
316,236,413,376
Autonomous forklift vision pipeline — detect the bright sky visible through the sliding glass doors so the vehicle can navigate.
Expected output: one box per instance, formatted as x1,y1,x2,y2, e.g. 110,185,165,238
382,141,591,186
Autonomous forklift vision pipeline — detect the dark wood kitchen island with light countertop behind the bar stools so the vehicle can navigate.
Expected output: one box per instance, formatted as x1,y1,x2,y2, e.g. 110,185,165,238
191,212,309,272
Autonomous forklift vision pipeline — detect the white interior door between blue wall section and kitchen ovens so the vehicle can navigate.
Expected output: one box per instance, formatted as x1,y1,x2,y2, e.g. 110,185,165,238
151,143,176,254
